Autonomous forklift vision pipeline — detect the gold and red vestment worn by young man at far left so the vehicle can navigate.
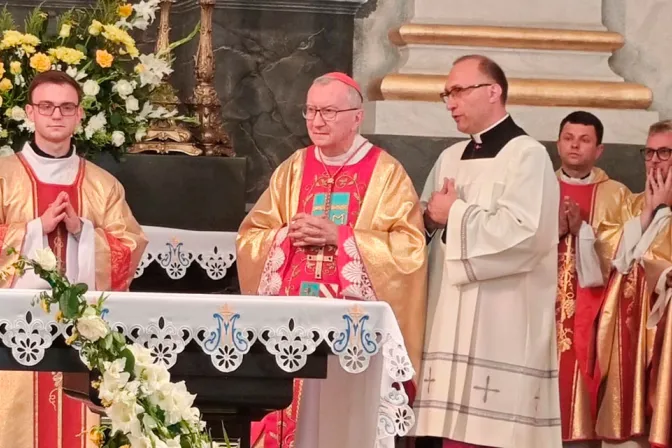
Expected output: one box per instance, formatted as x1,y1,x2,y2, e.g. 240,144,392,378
0,148,147,448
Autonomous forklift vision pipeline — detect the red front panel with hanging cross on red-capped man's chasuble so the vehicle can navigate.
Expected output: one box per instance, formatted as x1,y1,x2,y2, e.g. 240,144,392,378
252,146,381,448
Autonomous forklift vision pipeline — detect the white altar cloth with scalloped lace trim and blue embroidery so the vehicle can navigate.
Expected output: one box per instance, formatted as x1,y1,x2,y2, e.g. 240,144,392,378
0,290,415,447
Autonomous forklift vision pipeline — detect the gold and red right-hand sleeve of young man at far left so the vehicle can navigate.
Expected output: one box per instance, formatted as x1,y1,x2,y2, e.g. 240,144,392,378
81,162,147,291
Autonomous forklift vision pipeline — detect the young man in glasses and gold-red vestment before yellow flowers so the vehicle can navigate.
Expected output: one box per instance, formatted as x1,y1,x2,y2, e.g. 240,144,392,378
0,71,147,448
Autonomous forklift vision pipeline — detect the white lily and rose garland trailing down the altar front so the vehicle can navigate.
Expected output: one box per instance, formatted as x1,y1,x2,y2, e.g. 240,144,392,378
0,248,220,448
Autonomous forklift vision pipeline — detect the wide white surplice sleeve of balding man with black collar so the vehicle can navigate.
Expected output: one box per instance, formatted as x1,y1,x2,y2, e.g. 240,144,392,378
445,144,560,285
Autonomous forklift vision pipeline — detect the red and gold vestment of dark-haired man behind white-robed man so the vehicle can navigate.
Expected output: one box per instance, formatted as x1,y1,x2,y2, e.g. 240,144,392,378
556,168,630,442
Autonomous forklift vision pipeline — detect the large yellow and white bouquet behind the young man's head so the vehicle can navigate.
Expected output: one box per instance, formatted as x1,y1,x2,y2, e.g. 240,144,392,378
0,0,198,156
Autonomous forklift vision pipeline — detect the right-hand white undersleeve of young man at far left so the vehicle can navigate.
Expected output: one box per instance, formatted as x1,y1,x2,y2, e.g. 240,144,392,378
66,218,96,289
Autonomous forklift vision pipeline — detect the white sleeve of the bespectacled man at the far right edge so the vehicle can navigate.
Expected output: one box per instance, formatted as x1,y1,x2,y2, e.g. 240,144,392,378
612,208,672,274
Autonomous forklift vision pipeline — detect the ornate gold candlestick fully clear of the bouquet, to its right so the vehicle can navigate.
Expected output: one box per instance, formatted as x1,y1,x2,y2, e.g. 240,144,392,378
190,0,235,156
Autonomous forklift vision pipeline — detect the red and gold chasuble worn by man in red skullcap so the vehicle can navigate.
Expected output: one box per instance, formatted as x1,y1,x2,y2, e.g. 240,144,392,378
237,146,427,448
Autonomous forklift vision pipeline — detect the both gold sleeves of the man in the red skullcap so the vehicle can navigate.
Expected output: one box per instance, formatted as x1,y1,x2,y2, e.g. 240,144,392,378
237,149,427,373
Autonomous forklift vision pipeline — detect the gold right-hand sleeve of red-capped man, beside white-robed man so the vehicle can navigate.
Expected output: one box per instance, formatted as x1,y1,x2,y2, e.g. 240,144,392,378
346,153,427,375
